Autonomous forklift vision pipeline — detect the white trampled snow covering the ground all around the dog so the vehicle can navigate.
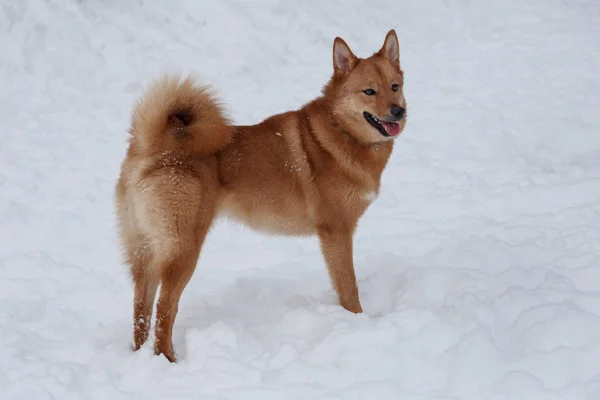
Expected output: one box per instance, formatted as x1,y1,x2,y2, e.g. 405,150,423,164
0,0,600,400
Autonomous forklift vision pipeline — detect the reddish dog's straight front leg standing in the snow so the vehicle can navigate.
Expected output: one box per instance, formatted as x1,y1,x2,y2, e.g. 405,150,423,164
318,227,362,313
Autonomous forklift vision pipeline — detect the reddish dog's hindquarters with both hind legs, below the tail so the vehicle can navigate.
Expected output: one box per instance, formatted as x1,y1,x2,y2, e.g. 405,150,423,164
123,160,219,361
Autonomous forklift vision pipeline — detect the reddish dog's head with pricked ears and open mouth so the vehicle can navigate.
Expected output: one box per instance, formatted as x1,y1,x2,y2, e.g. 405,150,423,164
323,29,406,143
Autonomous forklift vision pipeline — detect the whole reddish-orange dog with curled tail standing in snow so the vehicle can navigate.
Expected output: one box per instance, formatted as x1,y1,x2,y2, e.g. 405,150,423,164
116,30,406,361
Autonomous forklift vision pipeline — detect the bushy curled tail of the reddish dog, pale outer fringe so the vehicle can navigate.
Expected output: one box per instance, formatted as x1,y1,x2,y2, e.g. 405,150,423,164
129,75,232,155
